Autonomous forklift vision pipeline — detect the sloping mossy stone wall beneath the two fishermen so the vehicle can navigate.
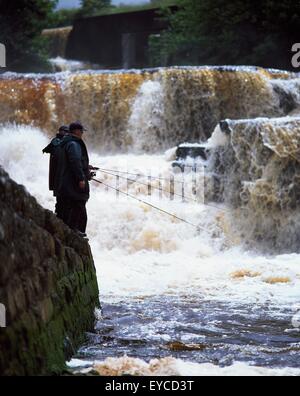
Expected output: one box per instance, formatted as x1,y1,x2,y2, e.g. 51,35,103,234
0,167,99,375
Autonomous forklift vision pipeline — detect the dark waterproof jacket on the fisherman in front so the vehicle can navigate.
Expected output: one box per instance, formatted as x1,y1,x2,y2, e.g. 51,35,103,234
55,135,91,201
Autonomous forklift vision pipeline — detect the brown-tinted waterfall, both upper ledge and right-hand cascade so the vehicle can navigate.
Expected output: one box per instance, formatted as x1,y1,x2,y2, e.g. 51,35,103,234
0,67,300,251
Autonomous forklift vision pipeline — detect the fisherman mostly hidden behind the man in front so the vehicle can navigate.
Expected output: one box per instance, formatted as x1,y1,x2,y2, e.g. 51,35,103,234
43,125,69,219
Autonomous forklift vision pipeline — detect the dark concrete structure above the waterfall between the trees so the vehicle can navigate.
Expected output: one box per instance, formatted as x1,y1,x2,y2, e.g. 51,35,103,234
66,7,176,69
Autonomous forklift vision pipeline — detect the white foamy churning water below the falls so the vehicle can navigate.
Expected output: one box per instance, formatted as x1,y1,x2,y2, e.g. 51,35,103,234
0,126,300,375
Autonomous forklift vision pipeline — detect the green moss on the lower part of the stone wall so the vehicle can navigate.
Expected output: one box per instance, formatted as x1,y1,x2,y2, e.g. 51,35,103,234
0,274,98,375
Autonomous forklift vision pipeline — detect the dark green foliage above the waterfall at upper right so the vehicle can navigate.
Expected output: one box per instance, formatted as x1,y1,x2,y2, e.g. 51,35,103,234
150,0,300,68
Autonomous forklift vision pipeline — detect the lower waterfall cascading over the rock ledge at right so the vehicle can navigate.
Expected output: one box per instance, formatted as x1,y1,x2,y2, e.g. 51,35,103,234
210,117,300,252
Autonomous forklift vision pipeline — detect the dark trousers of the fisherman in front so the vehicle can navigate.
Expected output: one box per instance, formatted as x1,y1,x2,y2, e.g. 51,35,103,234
62,198,87,233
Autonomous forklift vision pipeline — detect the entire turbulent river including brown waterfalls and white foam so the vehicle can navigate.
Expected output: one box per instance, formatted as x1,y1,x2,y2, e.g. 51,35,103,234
0,69,300,375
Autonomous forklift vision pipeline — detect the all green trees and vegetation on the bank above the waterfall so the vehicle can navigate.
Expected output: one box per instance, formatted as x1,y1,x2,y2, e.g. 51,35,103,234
0,0,300,72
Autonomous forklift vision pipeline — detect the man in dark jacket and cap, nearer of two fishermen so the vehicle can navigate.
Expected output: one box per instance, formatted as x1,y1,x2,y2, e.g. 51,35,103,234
56,122,91,237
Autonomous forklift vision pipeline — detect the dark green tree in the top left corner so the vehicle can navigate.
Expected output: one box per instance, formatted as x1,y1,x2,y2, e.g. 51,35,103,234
0,0,57,72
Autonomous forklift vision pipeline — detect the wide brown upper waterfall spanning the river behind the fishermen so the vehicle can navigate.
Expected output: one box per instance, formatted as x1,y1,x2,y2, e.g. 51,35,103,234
0,67,299,152
